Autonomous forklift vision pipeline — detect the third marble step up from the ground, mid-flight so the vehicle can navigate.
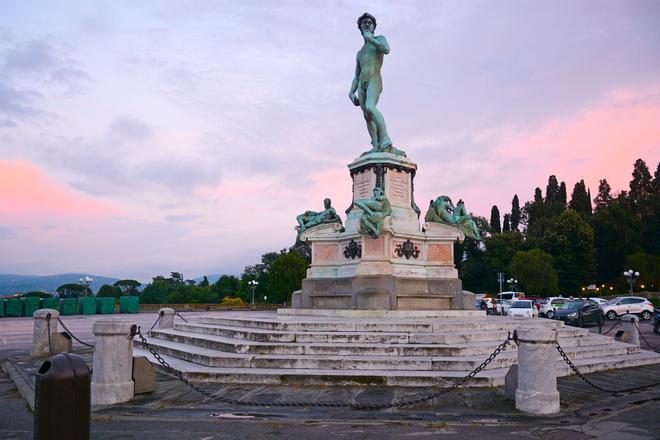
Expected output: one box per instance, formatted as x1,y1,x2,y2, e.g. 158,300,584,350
150,329,613,356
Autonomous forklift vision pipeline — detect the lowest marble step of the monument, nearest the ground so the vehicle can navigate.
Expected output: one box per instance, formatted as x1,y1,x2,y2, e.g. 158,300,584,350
135,347,660,387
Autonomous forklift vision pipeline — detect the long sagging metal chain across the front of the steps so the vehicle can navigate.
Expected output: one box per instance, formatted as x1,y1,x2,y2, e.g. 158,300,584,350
137,327,513,410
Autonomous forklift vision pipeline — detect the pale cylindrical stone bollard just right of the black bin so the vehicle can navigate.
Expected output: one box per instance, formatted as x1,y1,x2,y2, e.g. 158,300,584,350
91,320,134,405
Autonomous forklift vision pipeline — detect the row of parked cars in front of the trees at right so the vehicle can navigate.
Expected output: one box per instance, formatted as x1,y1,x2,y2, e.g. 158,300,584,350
480,293,657,327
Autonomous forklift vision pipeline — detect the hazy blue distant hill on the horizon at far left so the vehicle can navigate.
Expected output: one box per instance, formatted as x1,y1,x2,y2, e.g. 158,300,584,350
0,273,119,296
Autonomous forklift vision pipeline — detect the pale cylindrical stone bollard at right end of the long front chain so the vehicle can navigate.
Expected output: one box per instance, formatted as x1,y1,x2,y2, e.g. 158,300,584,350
516,324,559,414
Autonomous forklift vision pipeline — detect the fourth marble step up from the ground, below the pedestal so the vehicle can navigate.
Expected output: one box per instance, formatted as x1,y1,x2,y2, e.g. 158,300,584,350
174,323,589,344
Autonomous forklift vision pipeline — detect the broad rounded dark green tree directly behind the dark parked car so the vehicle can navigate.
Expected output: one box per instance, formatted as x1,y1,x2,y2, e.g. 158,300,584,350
541,209,596,294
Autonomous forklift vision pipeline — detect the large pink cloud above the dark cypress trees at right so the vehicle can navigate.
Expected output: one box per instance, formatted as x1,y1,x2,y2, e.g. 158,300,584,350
497,90,660,205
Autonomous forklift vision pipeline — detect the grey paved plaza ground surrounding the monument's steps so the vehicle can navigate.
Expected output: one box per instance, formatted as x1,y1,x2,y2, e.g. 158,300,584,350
0,312,660,440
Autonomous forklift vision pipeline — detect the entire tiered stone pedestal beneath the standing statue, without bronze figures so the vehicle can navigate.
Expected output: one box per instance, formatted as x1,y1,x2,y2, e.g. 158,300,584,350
296,153,474,310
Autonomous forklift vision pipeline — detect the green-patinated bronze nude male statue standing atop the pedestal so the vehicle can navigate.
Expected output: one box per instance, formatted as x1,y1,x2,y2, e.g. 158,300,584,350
348,12,405,156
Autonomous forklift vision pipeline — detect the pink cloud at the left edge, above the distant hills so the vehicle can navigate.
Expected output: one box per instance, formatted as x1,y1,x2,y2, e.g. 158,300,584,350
0,160,120,217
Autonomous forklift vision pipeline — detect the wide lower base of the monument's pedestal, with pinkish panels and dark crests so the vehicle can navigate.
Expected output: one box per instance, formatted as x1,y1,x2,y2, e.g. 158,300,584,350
292,223,474,310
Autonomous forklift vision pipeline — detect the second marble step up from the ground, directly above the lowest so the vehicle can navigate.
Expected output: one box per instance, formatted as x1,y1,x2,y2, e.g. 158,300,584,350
137,338,639,371
